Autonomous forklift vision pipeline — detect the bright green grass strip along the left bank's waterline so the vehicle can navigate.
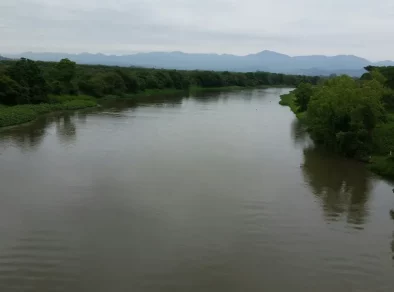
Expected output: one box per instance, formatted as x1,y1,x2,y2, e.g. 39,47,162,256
0,95,97,127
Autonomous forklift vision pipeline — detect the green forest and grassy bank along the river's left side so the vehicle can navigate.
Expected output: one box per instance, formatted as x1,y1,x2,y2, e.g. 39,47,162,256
0,58,320,127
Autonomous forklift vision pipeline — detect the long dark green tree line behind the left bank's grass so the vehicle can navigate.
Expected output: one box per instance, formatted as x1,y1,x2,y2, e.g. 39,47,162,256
0,58,320,105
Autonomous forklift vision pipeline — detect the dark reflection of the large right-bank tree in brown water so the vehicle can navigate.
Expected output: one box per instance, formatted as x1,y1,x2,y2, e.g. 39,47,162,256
302,147,371,225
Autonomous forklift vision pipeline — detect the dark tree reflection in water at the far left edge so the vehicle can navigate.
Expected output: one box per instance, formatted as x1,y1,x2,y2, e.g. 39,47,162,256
0,117,51,150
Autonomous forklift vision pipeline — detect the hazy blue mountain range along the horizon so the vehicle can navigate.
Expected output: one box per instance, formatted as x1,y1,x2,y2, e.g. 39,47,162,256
2,50,394,76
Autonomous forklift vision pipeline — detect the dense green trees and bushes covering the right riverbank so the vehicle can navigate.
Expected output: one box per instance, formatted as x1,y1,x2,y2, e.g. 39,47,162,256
281,67,394,178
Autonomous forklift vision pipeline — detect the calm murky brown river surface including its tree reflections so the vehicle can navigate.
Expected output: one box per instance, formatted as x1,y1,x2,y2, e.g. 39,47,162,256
0,89,394,292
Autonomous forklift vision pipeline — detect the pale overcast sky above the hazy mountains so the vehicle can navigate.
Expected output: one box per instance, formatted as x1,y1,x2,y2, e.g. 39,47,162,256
0,0,394,61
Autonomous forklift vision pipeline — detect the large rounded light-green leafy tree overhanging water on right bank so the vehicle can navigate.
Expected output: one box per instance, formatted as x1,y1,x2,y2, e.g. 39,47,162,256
307,76,385,158
